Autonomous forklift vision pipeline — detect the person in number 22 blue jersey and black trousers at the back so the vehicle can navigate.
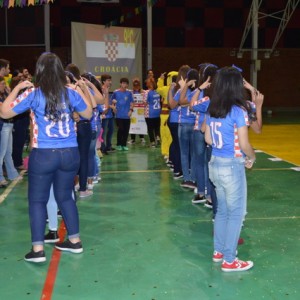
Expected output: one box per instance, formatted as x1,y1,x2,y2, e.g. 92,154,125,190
143,77,161,148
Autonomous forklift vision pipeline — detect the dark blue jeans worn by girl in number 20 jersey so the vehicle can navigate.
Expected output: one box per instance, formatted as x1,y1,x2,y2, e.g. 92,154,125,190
28,147,80,245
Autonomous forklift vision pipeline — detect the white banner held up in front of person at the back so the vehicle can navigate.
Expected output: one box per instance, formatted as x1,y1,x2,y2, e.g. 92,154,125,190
129,94,148,134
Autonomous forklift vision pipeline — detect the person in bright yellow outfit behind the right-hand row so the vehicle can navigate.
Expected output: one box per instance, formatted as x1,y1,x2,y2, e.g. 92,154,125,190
156,71,178,160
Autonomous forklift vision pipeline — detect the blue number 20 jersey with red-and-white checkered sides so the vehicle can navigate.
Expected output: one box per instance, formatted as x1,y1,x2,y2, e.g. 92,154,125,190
11,88,87,148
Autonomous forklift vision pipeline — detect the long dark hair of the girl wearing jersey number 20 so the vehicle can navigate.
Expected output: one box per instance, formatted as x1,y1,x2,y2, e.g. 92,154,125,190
35,52,69,121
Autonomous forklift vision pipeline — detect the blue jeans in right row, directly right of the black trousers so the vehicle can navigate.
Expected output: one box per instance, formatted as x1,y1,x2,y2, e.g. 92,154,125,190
178,123,196,181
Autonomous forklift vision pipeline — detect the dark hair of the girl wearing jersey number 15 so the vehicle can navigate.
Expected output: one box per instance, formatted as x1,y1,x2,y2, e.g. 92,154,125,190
208,67,249,118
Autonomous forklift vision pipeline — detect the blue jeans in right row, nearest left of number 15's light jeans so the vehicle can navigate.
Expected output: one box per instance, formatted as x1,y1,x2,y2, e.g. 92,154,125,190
191,130,206,195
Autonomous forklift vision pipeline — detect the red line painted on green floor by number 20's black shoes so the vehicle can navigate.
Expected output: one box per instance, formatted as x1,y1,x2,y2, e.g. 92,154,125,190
41,220,67,300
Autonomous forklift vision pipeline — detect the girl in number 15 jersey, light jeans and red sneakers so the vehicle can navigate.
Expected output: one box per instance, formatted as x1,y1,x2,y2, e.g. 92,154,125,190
205,67,255,272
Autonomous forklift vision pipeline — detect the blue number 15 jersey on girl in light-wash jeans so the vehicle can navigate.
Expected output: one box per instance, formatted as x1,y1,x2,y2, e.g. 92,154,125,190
206,106,249,158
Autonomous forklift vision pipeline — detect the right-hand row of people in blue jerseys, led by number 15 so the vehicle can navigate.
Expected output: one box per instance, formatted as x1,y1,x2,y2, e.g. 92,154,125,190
158,63,264,272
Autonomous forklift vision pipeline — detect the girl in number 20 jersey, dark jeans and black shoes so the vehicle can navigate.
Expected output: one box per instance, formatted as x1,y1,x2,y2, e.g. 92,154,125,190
0,53,92,263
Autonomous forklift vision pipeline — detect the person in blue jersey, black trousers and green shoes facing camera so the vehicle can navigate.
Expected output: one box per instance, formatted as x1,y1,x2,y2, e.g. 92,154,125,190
112,78,133,151
